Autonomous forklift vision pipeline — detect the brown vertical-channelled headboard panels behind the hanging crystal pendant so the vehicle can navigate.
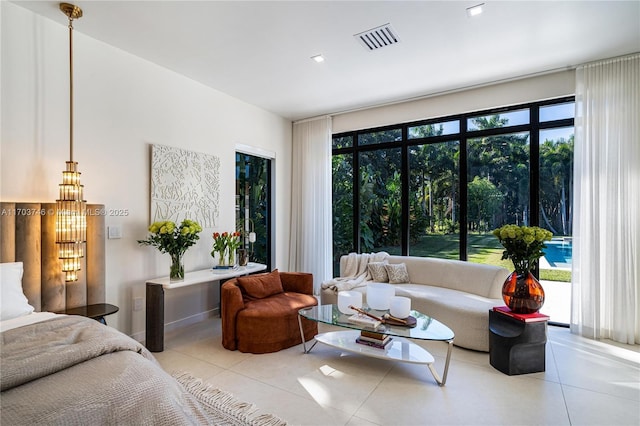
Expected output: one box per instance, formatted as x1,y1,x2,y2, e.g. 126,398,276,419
0,202,106,312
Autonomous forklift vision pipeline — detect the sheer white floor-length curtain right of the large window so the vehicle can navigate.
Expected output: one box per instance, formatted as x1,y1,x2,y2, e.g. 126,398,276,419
571,54,640,344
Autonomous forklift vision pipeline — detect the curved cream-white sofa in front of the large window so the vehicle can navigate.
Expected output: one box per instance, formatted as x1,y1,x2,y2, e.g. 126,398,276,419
321,255,510,352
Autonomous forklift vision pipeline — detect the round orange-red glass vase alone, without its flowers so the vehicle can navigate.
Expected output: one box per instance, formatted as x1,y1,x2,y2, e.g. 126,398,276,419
502,271,544,314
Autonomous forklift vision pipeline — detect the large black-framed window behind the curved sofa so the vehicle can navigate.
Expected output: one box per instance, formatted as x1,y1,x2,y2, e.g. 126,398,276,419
332,97,574,322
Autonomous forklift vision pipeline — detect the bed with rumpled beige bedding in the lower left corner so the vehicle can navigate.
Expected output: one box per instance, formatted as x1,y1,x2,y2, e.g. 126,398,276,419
0,313,226,425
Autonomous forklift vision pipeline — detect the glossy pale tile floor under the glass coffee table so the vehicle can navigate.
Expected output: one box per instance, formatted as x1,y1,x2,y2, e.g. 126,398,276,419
155,318,640,426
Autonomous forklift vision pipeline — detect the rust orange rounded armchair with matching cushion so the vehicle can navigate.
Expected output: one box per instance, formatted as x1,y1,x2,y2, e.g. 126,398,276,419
220,269,318,354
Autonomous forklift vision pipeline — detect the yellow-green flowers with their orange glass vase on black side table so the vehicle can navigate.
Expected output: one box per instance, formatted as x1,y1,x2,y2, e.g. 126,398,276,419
493,225,553,314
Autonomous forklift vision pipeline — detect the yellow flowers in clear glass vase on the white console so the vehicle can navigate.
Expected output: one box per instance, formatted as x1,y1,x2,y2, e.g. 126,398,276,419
138,219,202,281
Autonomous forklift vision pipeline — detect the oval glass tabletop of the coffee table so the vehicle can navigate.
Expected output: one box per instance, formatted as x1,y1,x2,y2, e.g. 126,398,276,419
298,305,454,341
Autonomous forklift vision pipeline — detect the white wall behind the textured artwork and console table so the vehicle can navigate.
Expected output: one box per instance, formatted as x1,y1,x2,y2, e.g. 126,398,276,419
0,2,291,338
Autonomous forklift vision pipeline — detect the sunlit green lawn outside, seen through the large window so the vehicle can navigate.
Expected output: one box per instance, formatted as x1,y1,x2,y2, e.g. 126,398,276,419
380,233,571,282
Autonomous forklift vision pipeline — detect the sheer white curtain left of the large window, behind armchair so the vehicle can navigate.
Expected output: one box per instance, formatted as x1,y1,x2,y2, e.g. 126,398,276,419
289,117,332,294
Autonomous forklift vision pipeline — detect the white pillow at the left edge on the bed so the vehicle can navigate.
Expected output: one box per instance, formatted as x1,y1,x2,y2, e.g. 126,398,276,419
0,262,33,321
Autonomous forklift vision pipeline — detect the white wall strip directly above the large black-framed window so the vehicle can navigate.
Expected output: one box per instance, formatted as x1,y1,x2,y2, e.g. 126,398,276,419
333,70,576,133
